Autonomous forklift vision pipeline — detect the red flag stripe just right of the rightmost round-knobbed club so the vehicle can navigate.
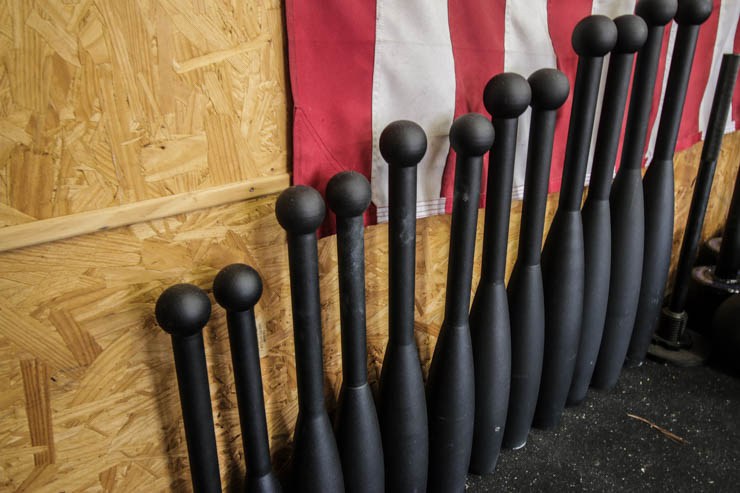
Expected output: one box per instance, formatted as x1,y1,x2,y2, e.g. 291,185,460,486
676,0,722,151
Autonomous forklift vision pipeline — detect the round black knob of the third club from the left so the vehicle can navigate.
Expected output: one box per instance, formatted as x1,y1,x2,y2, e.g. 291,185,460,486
275,185,326,235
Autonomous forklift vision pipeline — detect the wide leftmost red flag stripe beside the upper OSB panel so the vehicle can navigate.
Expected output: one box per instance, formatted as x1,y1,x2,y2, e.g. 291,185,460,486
285,0,375,234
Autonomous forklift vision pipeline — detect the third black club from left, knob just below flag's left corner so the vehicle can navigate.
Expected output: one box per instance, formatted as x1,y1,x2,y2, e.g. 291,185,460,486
275,185,344,493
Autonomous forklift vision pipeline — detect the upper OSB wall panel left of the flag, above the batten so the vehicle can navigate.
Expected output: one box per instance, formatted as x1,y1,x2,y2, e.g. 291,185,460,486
0,0,288,221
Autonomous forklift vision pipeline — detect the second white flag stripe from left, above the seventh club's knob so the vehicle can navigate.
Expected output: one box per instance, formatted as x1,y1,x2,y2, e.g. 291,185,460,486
504,0,557,199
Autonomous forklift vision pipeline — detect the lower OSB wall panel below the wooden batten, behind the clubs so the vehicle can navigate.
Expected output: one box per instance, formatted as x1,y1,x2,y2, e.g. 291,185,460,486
0,133,740,492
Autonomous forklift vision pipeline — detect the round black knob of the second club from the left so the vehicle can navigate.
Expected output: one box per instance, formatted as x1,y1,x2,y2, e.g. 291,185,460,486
213,264,262,312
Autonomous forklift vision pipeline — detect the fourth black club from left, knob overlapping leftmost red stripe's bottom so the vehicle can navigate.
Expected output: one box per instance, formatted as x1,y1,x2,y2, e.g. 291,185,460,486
326,171,385,493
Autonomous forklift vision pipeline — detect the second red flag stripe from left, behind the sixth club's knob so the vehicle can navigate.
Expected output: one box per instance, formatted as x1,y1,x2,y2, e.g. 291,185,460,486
442,0,506,209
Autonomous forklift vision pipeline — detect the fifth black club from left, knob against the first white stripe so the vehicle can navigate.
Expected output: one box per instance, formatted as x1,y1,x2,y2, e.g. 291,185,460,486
378,120,429,492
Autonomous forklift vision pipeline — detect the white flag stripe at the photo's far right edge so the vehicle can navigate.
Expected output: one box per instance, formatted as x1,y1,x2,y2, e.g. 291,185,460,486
699,1,740,136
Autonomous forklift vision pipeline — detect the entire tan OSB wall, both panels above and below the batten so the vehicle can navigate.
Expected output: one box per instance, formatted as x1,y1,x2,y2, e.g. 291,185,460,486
0,0,740,492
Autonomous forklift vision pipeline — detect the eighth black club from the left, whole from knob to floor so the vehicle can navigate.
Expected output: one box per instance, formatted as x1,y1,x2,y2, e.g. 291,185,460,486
502,69,570,449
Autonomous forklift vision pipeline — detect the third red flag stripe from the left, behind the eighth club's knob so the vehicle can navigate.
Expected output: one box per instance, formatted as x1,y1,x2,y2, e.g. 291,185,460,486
547,0,592,192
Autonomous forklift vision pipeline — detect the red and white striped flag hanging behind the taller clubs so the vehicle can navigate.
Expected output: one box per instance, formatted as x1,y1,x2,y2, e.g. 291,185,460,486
286,0,740,233
